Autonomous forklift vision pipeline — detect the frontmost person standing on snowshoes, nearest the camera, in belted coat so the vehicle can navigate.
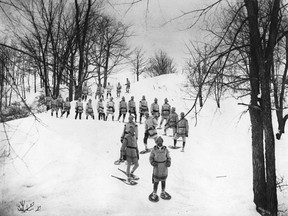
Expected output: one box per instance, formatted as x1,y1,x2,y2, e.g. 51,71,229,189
149,136,171,202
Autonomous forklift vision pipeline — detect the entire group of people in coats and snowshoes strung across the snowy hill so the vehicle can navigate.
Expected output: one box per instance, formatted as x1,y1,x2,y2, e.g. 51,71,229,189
46,78,189,201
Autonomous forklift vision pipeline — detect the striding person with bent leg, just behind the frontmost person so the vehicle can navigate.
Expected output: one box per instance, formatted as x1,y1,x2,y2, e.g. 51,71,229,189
143,112,158,152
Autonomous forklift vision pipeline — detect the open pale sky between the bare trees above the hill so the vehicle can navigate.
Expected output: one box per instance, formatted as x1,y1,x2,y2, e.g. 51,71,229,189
107,0,219,68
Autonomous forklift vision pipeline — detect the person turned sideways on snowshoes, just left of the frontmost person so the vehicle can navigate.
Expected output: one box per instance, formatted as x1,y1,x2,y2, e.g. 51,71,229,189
121,125,139,181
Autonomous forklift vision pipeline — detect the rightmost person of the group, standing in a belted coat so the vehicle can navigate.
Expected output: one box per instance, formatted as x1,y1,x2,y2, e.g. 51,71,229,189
173,112,189,152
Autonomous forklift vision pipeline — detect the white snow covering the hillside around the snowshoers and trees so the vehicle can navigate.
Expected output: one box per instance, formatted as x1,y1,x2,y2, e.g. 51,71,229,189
0,74,288,216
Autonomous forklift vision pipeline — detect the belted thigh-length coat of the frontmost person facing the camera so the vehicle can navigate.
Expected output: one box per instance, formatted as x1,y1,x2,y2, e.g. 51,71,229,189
149,145,171,182
